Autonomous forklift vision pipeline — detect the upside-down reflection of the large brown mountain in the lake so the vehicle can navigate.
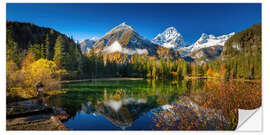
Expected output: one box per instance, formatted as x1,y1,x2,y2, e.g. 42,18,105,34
81,98,151,129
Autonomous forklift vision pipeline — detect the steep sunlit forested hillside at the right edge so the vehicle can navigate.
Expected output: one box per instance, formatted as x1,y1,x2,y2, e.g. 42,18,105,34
207,24,262,79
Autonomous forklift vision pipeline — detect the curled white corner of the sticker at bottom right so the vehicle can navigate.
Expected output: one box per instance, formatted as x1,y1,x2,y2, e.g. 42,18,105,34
236,107,262,131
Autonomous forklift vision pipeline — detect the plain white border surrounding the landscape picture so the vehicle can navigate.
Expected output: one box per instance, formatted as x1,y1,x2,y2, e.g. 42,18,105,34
0,0,270,135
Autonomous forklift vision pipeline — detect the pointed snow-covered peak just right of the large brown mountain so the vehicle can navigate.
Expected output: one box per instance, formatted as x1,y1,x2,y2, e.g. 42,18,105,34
152,27,184,48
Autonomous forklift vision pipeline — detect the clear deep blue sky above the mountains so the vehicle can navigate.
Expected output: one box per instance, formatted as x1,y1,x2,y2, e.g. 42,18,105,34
7,3,261,43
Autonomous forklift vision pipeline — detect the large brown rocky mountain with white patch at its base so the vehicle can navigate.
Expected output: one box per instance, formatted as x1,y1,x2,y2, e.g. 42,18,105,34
93,23,157,55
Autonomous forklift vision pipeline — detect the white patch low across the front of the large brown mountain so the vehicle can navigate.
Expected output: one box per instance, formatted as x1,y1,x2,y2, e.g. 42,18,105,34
103,41,148,55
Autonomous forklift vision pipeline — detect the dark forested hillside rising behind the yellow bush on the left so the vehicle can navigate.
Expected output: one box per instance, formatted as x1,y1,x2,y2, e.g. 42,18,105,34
7,21,81,70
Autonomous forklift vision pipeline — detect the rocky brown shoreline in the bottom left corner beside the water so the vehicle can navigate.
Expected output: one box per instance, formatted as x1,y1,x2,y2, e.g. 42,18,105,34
6,99,70,130
